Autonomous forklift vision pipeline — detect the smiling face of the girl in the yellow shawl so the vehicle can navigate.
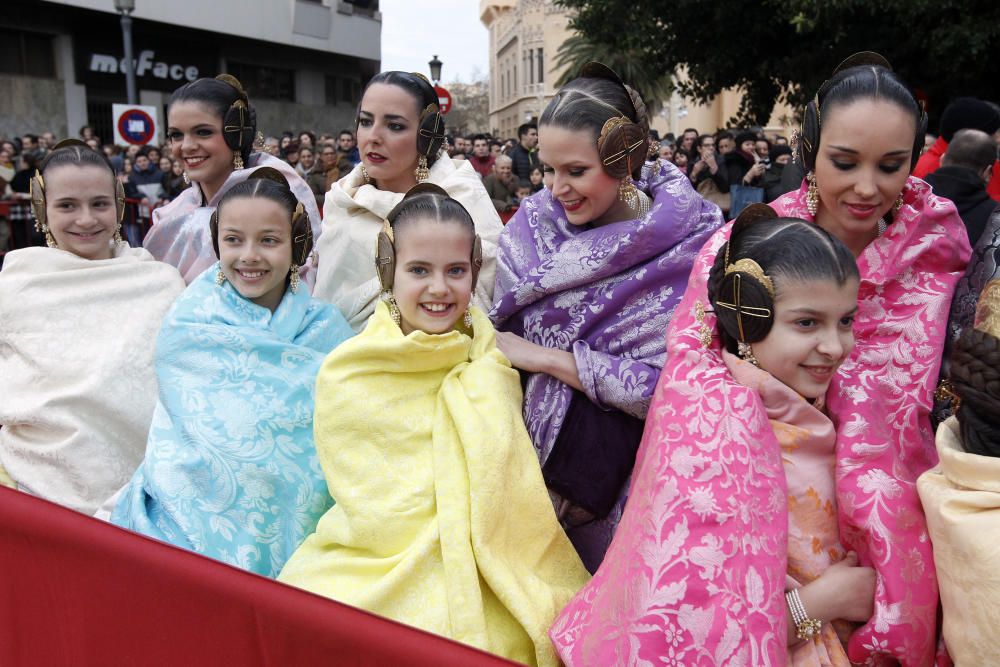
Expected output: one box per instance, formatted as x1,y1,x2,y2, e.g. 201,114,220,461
392,218,473,335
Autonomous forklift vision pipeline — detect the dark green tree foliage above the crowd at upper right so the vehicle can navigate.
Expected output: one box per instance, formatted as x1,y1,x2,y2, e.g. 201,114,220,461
558,0,1000,127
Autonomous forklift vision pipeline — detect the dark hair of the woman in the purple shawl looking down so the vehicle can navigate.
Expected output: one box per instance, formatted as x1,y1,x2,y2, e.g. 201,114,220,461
538,66,649,178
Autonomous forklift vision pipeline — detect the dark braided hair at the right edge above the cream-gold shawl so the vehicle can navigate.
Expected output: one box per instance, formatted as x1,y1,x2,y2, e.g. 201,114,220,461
951,327,1000,456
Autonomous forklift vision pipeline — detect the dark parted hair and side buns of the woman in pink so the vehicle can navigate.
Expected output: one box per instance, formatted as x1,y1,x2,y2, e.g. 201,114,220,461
801,52,927,171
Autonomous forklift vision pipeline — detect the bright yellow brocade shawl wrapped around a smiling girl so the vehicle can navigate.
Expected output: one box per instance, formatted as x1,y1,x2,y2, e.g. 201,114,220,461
280,302,589,665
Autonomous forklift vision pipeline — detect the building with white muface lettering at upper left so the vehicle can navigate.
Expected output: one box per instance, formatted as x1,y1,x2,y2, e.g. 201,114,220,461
0,0,381,141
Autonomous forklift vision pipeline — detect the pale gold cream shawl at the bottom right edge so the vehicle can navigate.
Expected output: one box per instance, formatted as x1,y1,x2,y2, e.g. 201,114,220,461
917,417,1000,667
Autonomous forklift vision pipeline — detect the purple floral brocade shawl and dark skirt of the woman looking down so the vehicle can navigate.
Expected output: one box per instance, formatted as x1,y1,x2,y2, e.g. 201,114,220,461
491,163,723,571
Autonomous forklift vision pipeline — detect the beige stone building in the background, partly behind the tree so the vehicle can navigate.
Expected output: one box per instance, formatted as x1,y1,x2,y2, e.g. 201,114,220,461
479,0,793,138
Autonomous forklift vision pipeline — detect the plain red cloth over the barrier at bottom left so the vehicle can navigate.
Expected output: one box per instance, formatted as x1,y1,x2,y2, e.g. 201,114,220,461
0,487,515,667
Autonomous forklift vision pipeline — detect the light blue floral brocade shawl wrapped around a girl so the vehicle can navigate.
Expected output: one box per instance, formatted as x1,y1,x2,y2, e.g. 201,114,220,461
112,266,352,577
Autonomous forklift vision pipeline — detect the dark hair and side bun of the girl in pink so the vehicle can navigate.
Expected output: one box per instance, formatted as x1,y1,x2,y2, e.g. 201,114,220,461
708,204,860,354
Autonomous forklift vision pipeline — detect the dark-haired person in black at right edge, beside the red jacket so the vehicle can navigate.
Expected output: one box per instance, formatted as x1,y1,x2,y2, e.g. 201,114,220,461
926,130,997,246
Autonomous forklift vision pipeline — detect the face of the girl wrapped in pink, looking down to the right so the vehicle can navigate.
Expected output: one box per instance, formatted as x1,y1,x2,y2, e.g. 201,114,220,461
752,278,858,399
